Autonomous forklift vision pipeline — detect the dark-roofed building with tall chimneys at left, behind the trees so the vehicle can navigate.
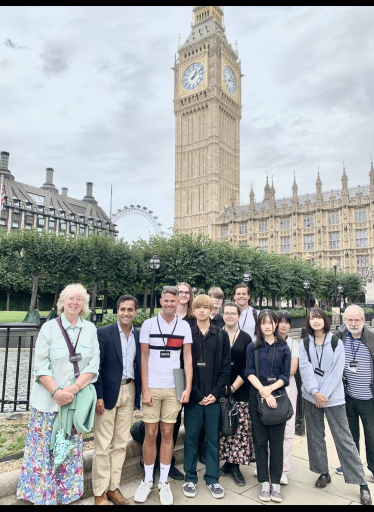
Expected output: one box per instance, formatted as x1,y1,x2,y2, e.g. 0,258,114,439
0,151,116,237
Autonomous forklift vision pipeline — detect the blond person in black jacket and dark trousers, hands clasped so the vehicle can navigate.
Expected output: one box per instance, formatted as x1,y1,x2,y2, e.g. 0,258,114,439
183,295,230,498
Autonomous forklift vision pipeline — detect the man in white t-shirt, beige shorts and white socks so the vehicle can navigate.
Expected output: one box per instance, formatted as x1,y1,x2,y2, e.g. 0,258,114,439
134,287,192,505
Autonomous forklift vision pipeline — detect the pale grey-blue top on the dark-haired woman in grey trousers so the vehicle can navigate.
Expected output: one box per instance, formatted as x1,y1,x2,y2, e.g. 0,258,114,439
299,332,345,407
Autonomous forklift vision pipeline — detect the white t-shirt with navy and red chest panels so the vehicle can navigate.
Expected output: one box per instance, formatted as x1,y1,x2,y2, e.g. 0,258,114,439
139,313,192,389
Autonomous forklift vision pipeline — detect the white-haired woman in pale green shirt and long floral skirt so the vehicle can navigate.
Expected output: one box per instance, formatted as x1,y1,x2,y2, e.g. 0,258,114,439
17,284,100,505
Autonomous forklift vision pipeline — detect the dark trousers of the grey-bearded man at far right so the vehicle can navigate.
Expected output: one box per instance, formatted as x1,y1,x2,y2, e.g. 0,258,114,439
345,394,374,473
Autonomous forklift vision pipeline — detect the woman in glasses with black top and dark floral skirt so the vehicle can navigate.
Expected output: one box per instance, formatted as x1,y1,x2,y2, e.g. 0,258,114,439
220,302,253,486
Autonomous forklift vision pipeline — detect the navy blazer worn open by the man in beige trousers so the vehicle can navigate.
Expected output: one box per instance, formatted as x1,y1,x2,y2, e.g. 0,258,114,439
94,322,141,409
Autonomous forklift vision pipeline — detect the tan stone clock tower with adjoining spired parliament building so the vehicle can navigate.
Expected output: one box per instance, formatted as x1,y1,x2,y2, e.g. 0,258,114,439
173,6,374,277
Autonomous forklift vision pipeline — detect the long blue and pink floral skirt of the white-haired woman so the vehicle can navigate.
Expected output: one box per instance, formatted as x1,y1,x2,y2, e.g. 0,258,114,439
17,408,83,505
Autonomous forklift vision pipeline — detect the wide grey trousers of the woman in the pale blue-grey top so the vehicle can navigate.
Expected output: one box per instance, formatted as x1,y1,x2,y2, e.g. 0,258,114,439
303,399,366,485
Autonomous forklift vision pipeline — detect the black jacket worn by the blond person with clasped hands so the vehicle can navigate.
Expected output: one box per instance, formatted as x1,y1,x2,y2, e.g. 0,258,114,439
185,324,231,407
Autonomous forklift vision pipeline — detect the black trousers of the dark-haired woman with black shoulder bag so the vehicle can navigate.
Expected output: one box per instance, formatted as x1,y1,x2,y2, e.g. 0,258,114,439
249,385,286,484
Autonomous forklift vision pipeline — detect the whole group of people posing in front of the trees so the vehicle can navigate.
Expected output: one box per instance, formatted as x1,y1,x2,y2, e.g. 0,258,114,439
17,282,374,505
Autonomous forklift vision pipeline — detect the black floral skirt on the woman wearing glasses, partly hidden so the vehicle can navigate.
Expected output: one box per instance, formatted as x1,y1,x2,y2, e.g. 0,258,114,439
219,402,253,466
